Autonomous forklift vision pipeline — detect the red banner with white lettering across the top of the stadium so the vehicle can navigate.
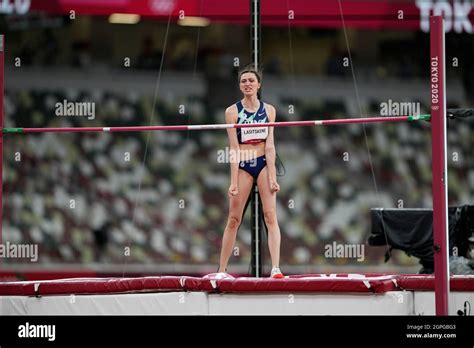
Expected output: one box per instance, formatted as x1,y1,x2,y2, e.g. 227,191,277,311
0,0,474,33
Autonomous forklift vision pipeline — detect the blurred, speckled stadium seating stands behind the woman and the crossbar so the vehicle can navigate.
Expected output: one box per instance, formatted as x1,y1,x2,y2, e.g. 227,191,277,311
3,85,474,267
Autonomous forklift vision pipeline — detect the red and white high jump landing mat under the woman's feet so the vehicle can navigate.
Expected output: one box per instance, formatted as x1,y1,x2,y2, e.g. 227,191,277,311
0,274,474,315
